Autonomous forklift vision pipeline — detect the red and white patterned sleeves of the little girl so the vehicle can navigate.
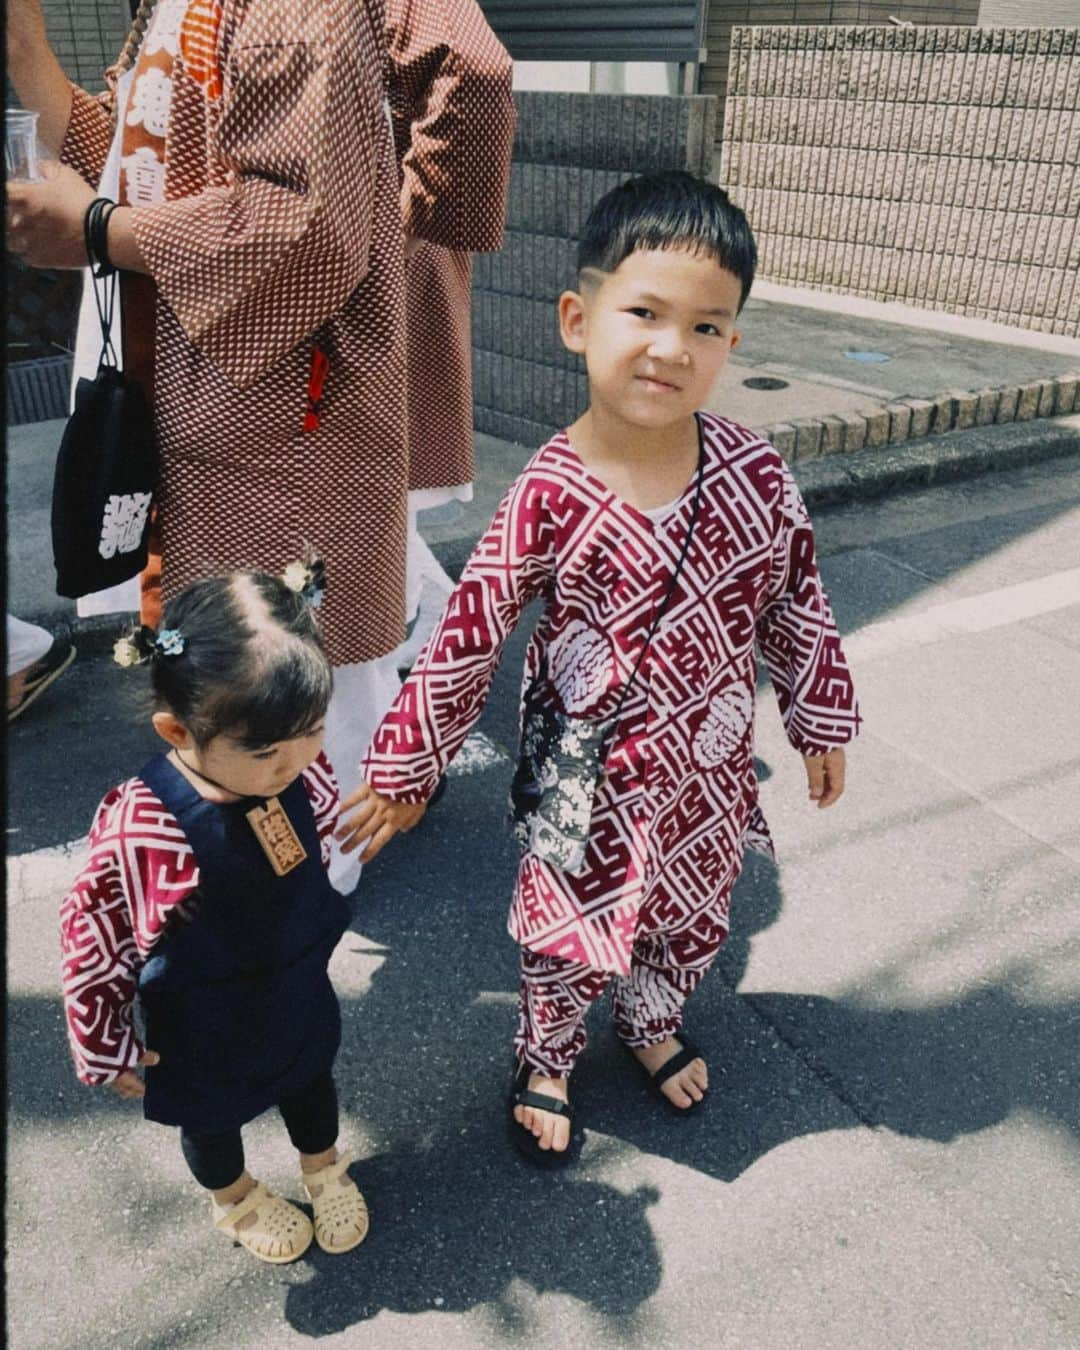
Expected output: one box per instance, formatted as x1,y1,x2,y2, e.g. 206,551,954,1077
59,755,339,1084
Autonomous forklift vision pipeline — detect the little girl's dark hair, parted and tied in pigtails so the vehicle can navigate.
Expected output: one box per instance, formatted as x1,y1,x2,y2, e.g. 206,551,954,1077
150,572,333,749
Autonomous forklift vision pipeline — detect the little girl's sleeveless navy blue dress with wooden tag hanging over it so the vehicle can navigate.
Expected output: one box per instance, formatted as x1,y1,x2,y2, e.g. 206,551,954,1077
138,755,350,1133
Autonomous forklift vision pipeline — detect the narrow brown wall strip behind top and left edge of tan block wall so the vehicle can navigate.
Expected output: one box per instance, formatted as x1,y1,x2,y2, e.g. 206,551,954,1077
701,0,977,143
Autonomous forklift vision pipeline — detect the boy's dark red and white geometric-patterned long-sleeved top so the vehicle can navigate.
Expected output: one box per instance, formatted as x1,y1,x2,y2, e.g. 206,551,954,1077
365,413,859,975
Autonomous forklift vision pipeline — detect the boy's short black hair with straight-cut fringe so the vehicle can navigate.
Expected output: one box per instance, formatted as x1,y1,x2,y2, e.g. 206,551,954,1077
578,170,757,309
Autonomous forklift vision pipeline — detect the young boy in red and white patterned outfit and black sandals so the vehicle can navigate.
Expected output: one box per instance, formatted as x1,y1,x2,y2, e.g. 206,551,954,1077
339,173,859,1160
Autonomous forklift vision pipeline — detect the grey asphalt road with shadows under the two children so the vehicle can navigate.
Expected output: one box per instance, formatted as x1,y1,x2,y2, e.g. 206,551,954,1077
7,458,1080,1350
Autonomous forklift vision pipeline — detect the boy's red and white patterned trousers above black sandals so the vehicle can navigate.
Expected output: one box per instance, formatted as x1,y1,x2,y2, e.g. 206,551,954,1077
514,896,728,1077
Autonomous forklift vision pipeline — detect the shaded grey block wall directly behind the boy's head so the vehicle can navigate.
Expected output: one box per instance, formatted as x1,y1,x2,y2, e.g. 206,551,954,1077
473,92,717,444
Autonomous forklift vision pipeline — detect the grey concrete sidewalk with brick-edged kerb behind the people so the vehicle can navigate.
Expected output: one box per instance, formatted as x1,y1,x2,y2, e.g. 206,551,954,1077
8,292,1080,629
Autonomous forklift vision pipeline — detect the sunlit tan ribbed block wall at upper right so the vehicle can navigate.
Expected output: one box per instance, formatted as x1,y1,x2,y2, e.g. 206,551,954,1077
721,27,1080,336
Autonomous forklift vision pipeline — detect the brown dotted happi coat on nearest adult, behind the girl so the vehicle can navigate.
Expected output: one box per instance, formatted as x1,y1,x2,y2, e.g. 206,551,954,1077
62,0,410,664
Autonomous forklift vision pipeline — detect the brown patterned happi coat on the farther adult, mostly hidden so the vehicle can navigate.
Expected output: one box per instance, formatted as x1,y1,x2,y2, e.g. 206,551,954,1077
386,0,516,489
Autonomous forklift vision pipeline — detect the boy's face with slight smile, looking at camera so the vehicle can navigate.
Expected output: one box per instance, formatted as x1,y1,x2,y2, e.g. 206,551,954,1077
559,248,743,429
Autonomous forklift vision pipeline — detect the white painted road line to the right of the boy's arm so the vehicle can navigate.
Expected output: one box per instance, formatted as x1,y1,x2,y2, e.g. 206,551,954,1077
844,567,1080,662
